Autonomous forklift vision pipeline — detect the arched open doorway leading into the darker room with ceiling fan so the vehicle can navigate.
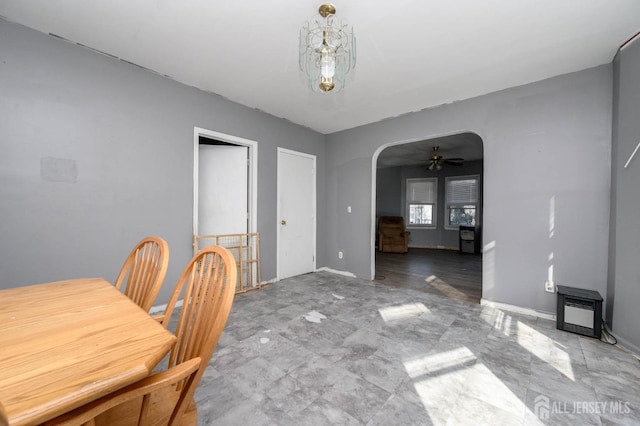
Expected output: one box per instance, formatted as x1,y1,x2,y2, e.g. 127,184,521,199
372,132,484,303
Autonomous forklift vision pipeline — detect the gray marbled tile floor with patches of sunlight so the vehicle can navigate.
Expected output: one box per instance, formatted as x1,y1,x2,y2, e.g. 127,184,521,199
185,272,640,426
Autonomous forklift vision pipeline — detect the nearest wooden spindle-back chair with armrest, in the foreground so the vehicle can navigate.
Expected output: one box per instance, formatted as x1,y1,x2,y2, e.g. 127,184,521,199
49,246,237,426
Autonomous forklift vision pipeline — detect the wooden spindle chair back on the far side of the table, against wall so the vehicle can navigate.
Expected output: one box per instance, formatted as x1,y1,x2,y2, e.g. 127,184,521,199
115,236,169,312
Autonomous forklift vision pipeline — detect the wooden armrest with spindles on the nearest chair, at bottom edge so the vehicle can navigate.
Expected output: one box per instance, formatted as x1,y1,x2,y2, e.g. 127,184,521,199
44,358,201,426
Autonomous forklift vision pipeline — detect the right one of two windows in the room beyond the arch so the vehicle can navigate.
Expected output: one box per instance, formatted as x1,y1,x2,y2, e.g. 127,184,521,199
445,175,480,228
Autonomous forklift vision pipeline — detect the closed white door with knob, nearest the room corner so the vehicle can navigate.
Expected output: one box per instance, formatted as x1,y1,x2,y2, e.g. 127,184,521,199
277,148,316,279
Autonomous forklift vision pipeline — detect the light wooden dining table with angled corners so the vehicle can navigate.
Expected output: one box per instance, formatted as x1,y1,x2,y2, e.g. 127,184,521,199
0,278,176,426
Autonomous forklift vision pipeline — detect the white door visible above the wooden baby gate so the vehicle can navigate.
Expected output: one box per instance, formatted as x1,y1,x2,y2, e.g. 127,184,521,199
198,144,249,235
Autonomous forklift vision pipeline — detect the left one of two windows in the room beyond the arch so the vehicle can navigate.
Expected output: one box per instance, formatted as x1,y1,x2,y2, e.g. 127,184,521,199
407,178,438,227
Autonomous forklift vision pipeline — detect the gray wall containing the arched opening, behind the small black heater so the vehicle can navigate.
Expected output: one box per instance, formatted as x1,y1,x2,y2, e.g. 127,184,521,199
325,65,612,312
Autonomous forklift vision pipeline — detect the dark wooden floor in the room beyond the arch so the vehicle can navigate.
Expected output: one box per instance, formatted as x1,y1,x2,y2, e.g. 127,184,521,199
375,248,482,303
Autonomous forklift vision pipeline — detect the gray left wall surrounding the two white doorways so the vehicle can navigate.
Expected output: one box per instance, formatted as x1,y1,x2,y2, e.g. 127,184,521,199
0,19,327,303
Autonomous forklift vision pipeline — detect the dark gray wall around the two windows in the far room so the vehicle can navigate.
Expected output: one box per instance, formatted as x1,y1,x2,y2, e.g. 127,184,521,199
376,160,482,249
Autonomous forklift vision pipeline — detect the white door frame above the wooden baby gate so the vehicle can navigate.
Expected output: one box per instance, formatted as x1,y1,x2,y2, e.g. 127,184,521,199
193,127,258,235
